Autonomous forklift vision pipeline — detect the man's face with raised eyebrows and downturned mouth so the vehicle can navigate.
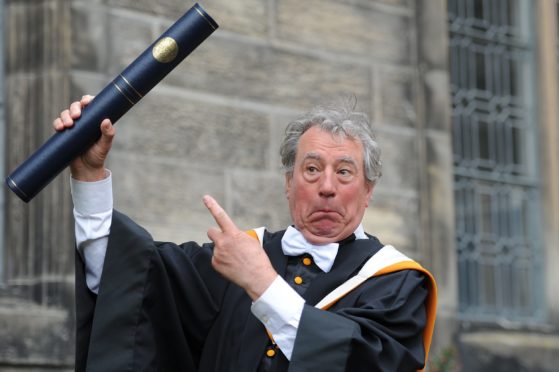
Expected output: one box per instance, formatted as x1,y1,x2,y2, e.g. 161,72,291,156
286,127,373,244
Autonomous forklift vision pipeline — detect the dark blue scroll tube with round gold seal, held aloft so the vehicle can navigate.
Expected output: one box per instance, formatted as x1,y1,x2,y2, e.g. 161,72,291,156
6,4,218,203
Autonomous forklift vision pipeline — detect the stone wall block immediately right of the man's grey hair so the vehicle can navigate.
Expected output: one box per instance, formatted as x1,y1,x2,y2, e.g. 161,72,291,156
375,126,420,195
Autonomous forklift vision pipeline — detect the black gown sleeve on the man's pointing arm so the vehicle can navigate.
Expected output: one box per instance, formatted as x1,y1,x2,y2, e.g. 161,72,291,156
289,270,428,372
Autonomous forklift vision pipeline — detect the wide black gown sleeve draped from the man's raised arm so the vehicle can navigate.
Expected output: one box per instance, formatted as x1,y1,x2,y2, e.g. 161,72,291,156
76,211,227,372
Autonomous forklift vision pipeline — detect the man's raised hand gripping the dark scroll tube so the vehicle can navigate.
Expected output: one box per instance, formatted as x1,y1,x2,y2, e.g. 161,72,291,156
52,95,115,181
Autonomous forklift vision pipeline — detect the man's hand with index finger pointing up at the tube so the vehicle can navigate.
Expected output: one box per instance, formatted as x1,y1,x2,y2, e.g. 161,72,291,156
203,195,278,301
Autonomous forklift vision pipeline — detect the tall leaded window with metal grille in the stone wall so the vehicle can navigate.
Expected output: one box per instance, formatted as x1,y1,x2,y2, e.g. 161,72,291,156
448,0,543,322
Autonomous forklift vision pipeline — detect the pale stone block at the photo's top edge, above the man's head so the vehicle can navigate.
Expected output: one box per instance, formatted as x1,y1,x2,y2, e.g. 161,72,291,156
277,0,412,64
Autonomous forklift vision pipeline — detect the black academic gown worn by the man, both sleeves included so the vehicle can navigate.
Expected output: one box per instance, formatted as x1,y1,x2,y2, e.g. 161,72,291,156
76,211,427,372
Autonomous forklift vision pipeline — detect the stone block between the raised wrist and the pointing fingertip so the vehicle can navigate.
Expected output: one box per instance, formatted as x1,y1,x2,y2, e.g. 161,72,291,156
108,151,224,243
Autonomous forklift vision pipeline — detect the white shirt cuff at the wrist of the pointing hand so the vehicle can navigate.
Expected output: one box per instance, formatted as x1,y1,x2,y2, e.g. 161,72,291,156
251,275,305,360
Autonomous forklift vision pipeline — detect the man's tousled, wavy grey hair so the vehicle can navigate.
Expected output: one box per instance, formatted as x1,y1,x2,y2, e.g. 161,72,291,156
280,102,382,185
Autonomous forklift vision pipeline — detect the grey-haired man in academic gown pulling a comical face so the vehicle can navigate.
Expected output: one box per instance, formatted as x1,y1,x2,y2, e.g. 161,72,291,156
53,96,435,372
